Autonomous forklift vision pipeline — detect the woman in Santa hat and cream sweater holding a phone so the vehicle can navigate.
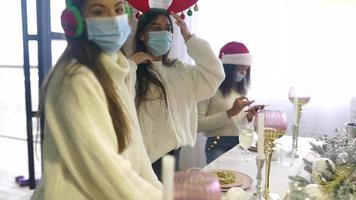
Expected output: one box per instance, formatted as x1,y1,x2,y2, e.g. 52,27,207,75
198,42,262,163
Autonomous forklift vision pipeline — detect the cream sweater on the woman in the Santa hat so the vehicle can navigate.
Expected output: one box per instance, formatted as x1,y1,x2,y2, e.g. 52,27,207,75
198,89,248,137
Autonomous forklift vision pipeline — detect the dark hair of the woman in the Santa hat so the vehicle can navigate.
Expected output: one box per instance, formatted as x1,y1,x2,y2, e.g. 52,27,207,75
219,64,251,97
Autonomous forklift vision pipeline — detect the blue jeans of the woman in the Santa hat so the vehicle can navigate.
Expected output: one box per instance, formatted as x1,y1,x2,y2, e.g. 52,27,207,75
205,136,240,164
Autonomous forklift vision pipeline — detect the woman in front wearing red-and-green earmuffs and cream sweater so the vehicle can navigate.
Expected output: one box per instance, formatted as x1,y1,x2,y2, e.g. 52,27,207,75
32,0,162,200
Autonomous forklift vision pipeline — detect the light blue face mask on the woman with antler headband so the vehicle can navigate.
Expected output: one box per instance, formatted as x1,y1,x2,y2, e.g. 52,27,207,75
146,31,173,57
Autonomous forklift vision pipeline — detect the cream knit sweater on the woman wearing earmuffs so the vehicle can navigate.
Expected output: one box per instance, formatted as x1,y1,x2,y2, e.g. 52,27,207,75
32,53,162,200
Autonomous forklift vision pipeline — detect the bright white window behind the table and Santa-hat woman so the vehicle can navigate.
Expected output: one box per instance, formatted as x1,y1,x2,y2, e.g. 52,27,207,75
197,0,356,133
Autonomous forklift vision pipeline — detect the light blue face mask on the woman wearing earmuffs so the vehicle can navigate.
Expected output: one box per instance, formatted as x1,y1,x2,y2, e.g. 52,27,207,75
86,14,131,54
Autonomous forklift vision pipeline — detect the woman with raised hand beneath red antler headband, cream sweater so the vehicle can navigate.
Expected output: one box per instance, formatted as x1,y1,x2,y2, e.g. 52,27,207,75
134,9,224,179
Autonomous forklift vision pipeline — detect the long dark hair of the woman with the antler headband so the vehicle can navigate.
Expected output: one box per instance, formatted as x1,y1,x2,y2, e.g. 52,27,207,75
134,9,174,108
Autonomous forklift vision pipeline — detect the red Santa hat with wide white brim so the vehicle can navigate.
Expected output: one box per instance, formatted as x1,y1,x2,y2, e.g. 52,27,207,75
219,42,252,65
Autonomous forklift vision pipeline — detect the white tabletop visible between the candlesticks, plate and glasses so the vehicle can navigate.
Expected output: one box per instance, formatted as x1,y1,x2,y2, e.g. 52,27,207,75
203,135,318,199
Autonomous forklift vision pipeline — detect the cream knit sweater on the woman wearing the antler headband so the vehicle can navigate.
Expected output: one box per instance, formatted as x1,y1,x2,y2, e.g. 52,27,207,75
138,35,225,162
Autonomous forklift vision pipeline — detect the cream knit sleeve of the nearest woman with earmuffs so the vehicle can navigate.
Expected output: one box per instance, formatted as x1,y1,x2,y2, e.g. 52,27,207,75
45,73,161,200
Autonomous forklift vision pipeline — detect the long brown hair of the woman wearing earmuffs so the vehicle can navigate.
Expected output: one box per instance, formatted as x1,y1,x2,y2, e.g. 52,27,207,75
40,0,130,153
